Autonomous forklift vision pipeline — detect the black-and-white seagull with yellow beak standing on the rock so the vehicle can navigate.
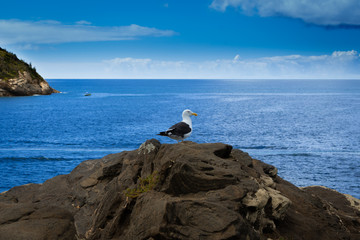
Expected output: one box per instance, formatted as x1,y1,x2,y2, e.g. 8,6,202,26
157,109,197,142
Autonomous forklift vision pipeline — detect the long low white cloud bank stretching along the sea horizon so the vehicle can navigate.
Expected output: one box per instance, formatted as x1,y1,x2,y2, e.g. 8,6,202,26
36,50,360,79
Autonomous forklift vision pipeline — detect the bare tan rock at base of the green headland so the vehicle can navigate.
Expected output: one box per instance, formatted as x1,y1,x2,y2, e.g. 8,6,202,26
0,71,59,97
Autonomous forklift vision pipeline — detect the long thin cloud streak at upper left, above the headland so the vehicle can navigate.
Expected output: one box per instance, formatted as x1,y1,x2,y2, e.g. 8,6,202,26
0,20,176,45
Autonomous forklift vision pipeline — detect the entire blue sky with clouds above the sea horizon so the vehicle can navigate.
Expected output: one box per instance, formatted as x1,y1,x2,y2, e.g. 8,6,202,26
0,0,360,79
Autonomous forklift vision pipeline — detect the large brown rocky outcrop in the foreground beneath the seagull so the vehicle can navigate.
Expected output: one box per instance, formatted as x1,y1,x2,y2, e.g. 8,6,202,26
0,139,360,240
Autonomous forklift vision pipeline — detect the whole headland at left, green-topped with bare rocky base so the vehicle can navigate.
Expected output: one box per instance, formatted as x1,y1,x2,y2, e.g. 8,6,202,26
0,48,59,97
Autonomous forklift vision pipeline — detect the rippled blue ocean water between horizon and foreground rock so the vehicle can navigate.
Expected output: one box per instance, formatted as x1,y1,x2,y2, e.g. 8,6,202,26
0,79,360,198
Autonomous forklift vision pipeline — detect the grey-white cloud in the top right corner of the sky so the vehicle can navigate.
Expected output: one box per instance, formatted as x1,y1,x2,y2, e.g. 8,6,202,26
211,0,360,26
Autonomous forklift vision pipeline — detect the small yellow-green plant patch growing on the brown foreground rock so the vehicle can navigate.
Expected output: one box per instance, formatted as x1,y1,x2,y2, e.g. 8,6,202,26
124,171,159,198
